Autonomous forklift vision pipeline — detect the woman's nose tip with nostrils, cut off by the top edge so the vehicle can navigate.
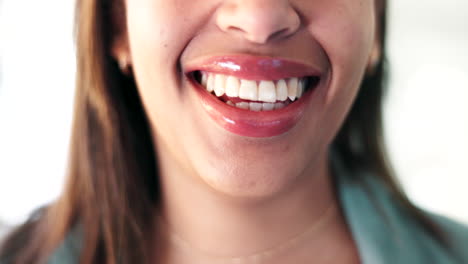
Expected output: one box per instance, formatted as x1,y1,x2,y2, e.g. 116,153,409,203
216,0,300,44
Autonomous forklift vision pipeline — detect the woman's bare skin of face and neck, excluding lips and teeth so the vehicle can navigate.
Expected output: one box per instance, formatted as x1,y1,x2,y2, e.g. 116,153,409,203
112,0,378,263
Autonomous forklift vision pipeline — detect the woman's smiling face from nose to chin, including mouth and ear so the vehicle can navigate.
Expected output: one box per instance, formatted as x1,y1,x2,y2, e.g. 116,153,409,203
113,0,376,196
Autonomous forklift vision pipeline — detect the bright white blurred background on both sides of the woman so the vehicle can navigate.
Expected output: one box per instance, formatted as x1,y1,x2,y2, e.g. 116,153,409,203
0,0,468,237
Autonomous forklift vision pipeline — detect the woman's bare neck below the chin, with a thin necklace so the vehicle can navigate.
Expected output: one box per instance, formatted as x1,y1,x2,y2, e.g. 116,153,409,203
157,150,352,263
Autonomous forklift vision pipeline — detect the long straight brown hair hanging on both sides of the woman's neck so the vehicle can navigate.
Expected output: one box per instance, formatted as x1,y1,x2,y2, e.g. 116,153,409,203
0,0,446,264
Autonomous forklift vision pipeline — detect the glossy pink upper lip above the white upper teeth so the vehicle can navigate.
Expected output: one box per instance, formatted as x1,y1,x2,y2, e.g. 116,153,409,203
184,54,322,81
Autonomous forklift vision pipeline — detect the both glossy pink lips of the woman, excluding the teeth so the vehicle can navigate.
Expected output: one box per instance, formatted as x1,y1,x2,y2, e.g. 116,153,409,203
186,55,321,138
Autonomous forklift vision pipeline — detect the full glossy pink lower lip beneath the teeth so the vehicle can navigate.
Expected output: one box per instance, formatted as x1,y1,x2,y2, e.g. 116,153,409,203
190,79,317,138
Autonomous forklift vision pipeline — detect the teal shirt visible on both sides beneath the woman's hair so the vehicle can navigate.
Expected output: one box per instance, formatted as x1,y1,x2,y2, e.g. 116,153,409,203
40,162,468,264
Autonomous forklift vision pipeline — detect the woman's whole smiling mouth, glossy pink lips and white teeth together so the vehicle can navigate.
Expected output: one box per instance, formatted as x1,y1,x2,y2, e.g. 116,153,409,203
186,55,322,137
